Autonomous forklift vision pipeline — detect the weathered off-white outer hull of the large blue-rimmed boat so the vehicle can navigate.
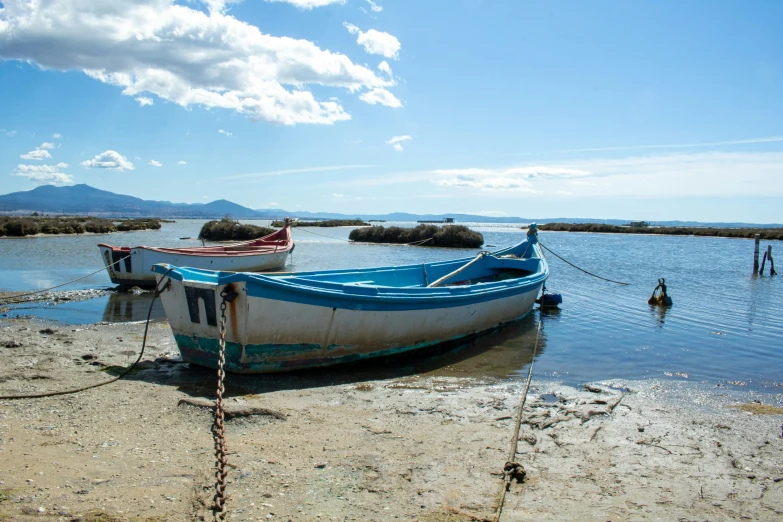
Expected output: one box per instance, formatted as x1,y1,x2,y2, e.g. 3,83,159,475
161,280,541,373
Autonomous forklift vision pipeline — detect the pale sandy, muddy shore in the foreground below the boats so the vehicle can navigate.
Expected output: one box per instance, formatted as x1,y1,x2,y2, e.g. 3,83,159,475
0,319,783,522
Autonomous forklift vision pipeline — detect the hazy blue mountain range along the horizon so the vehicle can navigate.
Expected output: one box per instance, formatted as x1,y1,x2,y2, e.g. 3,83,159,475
0,184,783,227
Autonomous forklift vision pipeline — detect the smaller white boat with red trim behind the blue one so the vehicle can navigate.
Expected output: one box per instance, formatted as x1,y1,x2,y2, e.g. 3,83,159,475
98,218,294,286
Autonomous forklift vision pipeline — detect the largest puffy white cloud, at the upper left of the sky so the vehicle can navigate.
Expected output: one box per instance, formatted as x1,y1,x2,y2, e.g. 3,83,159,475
0,0,396,125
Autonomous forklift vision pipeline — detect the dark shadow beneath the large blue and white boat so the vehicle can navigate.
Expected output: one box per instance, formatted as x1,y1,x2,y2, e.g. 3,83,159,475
121,304,547,399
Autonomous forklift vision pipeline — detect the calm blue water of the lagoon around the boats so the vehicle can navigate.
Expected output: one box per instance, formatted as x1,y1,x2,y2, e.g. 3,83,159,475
0,220,783,389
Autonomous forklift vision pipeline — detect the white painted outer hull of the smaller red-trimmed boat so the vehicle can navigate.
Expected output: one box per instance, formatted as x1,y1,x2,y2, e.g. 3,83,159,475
98,246,290,286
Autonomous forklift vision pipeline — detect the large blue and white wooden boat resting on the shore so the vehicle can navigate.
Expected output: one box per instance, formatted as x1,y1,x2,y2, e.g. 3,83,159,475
153,225,549,373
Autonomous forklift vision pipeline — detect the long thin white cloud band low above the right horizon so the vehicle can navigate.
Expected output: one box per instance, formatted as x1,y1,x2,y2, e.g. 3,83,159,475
428,152,783,198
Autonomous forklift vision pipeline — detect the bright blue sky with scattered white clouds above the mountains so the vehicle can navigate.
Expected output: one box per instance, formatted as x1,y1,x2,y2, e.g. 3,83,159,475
0,0,783,223
